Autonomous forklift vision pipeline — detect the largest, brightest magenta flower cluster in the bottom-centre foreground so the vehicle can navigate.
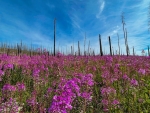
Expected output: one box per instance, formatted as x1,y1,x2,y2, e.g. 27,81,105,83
48,79,80,113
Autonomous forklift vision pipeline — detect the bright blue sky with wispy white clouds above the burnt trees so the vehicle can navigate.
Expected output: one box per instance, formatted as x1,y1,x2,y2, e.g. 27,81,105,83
0,0,150,55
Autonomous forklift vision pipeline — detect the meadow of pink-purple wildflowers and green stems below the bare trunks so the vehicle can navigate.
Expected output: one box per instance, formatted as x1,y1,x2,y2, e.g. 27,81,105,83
0,53,150,113
